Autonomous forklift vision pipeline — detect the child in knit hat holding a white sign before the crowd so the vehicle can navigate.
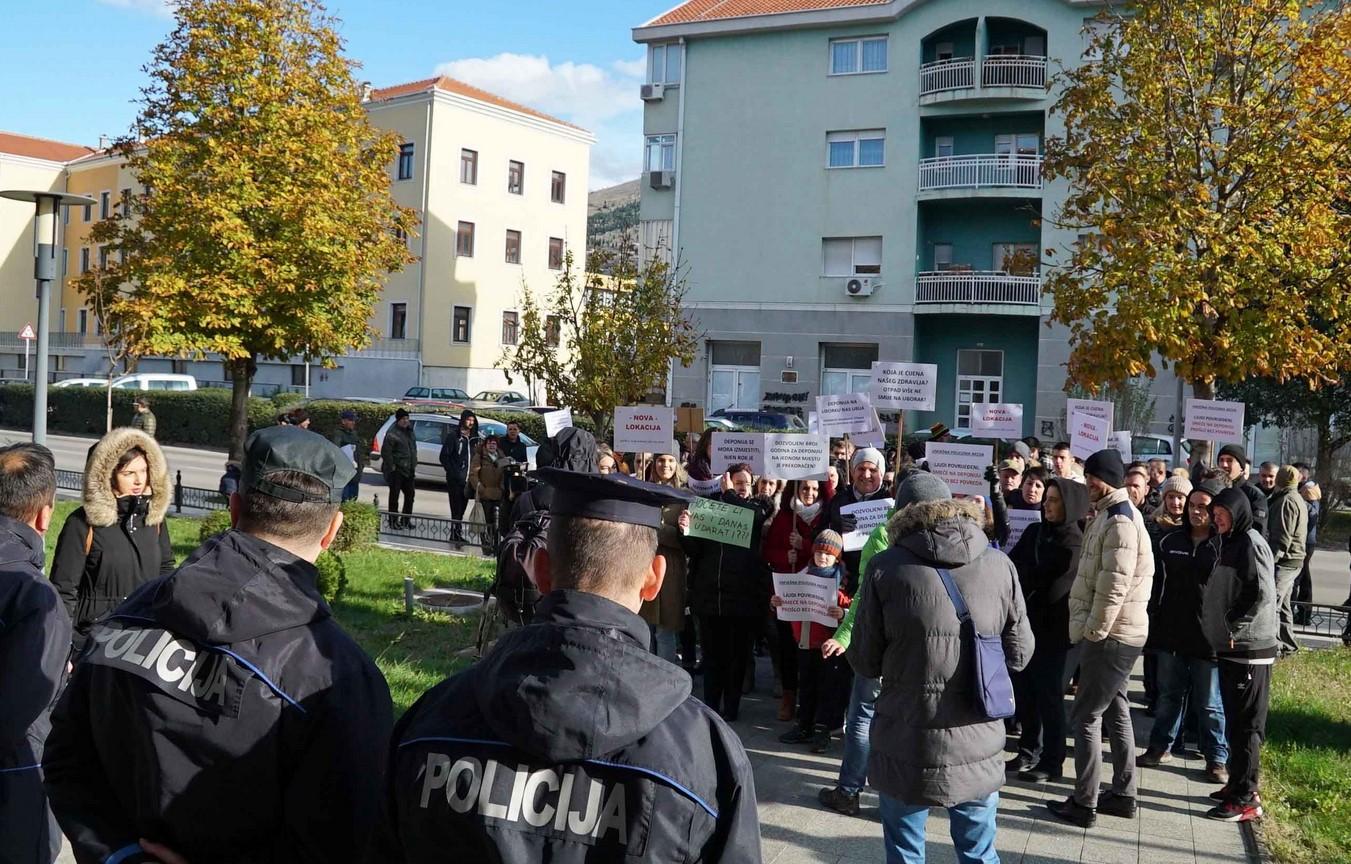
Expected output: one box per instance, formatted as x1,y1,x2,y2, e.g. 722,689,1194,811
769,531,851,753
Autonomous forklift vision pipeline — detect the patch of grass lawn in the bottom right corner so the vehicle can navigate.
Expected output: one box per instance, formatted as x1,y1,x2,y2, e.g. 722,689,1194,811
1262,648,1351,864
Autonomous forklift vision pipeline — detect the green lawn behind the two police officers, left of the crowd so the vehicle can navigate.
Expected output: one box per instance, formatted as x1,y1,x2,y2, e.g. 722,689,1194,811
47,501,493,716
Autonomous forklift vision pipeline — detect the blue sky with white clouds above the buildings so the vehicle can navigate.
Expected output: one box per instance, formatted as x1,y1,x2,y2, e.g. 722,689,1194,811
0,0,676,188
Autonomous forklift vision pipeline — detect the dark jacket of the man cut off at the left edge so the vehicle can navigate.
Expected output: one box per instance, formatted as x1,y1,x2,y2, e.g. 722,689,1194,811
0,516,70,864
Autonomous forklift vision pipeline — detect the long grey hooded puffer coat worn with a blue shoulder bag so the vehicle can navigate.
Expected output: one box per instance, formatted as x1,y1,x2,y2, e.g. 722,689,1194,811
848,501,1034,807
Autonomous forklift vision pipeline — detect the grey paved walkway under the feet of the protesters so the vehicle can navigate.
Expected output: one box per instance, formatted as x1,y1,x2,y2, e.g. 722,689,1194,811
729,662,1250,864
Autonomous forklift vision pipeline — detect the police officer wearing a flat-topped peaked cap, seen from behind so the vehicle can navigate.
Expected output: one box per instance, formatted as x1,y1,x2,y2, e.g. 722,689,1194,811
370,468,761,864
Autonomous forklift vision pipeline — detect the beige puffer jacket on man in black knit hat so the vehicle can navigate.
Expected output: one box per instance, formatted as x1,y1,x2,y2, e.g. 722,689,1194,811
1070,489,1154,645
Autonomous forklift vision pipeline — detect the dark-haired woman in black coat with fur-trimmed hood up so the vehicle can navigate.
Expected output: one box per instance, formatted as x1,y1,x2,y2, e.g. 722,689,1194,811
51,427,174,653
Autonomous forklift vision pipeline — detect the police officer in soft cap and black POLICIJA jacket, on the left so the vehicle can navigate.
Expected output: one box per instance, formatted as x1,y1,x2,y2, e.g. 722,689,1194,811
43,427,392,864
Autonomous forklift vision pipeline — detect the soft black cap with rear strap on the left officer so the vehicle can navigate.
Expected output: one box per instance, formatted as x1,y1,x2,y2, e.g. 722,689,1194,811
240,427,357,504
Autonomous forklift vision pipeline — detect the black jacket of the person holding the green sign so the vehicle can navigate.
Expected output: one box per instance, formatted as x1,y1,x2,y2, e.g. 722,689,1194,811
681,490,774,618
